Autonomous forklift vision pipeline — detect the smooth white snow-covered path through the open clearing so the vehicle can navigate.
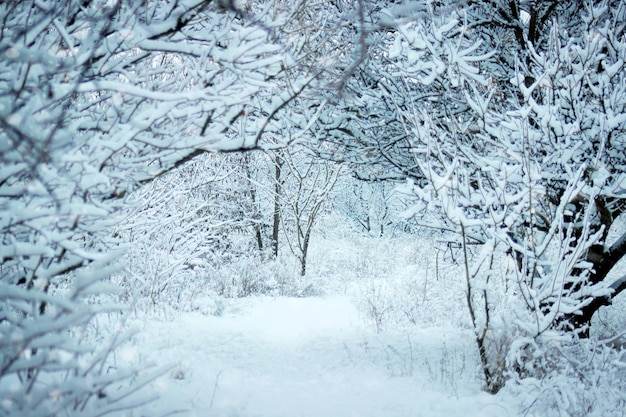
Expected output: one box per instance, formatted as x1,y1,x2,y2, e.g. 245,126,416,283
135,296,516,417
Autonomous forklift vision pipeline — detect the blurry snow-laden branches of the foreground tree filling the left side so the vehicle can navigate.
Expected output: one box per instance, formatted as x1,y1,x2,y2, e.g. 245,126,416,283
0,0,304,417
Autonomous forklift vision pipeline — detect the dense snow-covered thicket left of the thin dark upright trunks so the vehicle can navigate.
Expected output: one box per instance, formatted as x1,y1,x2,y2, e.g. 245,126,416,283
114,154,332,312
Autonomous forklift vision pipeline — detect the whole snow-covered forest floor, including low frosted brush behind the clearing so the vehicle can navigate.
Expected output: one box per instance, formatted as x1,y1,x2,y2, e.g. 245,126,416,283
111,231,624,417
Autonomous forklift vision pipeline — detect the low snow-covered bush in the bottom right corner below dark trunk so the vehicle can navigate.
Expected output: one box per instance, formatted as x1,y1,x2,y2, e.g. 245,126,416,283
507,335,626,417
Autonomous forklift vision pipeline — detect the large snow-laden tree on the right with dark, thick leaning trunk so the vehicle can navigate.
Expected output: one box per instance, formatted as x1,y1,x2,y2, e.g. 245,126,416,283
319,1,626,390
